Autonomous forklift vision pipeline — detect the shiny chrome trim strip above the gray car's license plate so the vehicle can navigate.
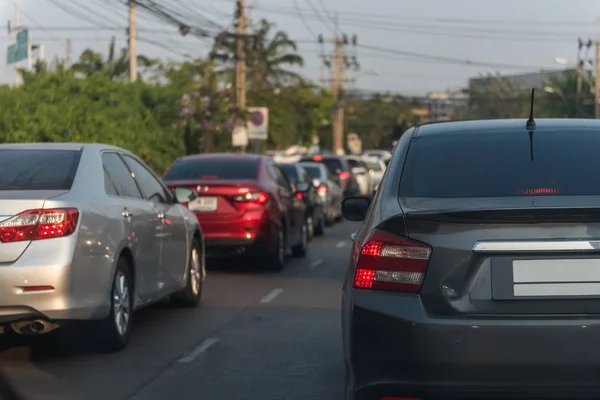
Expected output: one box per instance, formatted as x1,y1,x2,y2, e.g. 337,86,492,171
473,240,600,253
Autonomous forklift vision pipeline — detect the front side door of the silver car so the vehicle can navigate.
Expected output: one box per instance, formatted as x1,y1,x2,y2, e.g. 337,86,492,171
123,154,188,295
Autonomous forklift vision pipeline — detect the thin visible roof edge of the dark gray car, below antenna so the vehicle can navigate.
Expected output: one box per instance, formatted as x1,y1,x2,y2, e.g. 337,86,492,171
414,118,600,136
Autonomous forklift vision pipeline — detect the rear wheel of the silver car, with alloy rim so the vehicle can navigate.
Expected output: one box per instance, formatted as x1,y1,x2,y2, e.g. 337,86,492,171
97,257,134,352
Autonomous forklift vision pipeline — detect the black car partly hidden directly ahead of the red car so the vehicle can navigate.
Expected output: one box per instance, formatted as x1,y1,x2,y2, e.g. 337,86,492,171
279,163,326,239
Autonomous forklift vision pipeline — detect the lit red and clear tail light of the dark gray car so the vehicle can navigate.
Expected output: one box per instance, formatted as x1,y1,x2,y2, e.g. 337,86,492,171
354,229,431,293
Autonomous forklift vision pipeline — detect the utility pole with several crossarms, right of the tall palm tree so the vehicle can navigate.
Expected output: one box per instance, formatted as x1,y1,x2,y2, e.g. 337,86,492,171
319,16,358,154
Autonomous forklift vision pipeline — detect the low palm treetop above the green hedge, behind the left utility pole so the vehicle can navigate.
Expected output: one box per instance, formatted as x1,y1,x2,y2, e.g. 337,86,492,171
71,37,156,79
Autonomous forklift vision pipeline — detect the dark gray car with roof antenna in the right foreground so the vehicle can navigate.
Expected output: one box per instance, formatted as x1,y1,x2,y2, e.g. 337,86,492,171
342,120,600,400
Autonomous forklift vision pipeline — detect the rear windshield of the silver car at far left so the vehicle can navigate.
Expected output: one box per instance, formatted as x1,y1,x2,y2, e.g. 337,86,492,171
0,149,81,190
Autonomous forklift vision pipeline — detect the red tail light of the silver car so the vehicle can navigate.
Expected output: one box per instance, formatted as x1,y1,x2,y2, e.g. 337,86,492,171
0,208,79,243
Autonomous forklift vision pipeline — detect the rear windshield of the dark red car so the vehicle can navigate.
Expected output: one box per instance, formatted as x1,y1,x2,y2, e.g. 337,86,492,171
164,158,258,181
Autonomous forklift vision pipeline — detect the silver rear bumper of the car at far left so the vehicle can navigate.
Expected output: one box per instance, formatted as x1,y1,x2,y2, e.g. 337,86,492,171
0,236,112,324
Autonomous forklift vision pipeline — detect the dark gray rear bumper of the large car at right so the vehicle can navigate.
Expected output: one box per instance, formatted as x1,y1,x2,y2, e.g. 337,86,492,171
343,290,600,400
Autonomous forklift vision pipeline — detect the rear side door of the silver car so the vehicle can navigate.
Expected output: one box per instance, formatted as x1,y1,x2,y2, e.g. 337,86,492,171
102,152,160,303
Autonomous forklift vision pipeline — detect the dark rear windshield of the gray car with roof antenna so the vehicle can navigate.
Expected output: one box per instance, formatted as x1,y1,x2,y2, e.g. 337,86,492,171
400,131,600,198
